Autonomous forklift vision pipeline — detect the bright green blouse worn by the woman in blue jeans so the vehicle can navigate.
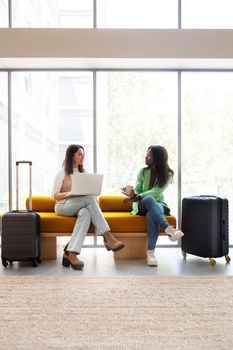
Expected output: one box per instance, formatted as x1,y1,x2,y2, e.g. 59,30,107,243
131,168,172,215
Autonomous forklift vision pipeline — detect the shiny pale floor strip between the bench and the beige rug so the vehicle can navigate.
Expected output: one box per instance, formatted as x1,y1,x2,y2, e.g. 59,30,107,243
0,239,233,277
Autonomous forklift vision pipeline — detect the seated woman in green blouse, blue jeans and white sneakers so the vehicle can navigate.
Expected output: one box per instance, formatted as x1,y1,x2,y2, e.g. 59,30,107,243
122,145,184,266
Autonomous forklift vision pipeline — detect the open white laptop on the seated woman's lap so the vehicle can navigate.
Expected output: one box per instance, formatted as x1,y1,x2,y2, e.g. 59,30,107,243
70,172,104,196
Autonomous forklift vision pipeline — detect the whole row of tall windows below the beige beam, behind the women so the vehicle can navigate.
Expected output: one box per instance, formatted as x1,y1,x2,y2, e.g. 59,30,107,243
0,71,233,244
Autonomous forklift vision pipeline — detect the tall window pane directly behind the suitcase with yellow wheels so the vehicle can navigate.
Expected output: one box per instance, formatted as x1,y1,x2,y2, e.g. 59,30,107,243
182,72,233,243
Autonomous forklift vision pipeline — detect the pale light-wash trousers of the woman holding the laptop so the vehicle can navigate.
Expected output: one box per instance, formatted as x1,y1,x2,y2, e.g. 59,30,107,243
55,196,110,254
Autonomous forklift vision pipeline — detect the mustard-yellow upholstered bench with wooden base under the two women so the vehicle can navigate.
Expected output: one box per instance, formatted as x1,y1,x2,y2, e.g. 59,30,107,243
26,195,176,259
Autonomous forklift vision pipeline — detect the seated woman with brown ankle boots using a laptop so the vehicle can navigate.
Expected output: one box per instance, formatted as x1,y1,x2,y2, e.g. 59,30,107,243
53,145,124,270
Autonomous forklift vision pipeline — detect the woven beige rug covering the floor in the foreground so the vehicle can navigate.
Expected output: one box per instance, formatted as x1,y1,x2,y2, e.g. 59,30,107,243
0,276,233,350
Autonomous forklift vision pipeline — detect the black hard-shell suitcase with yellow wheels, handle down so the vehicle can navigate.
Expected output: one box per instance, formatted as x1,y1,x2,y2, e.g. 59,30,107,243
181,196,230,265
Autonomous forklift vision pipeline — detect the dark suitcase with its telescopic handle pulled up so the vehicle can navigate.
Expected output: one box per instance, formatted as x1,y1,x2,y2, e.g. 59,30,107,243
2,161,41,267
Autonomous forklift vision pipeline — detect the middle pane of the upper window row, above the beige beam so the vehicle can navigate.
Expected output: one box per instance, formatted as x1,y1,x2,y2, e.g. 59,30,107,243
97,0,178,28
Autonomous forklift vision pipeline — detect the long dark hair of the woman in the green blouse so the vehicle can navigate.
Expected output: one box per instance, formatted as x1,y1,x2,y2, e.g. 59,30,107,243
144,145,174,188
